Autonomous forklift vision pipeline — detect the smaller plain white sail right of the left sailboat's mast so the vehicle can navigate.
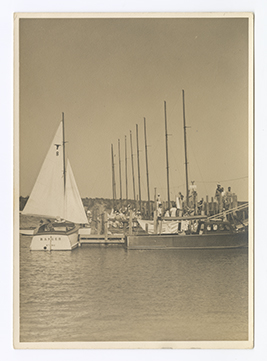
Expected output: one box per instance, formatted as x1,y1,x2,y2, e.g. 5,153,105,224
65,160,88,224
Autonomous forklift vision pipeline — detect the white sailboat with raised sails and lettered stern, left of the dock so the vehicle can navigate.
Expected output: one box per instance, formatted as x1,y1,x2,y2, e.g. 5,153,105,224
22,113,88,251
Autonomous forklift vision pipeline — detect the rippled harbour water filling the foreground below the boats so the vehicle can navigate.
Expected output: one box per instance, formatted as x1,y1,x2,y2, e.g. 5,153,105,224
20,236,248,342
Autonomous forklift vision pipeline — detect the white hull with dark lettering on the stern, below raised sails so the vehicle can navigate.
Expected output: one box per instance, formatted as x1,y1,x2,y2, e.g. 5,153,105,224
30,227,79,251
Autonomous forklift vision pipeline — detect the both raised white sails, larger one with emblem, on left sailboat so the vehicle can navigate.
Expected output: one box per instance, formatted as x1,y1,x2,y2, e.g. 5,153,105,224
22,122,88,224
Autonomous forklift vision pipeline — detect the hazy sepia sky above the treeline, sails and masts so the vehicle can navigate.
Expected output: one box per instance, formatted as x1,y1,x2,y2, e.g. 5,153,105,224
19,18,248,200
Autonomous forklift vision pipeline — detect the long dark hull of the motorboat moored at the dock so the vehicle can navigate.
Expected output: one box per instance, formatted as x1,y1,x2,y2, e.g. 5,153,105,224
126,232,248,250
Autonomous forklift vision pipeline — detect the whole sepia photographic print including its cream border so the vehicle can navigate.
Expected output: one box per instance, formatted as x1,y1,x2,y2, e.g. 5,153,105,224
14,13,254,348
